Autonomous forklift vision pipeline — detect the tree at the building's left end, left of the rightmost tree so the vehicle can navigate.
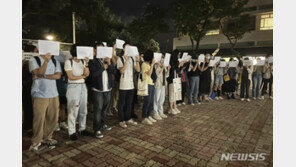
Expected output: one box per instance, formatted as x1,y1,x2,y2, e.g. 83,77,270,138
172,0,215,51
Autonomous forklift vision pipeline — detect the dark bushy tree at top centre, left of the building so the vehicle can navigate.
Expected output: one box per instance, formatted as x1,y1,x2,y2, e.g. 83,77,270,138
127,4,168,52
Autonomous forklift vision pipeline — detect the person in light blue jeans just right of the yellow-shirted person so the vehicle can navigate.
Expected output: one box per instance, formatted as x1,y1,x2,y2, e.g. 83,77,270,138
153,53,170,120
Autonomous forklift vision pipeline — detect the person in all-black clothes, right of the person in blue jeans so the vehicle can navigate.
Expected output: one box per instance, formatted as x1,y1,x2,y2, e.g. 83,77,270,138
199,53,212,102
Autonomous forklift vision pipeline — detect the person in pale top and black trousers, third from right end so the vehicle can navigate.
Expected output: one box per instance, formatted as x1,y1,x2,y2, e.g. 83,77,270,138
240,57,253,102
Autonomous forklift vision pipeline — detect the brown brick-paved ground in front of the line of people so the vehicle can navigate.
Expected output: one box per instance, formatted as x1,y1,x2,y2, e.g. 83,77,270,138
22,99,273,167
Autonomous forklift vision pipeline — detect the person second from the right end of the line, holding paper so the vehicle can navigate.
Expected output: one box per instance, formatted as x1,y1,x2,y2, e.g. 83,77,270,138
252,57,263,100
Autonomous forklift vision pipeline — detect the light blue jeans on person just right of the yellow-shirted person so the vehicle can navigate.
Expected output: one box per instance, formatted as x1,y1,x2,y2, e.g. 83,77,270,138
153,86,165,115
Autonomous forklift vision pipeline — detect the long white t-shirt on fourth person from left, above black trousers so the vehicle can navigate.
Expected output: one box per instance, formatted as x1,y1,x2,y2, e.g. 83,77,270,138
117,58,136,90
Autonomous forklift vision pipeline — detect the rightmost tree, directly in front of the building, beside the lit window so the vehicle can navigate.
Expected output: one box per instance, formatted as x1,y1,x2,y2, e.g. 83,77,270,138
214,0,253,58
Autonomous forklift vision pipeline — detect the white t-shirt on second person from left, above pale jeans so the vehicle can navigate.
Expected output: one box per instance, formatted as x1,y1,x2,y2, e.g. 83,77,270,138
65,60,85,83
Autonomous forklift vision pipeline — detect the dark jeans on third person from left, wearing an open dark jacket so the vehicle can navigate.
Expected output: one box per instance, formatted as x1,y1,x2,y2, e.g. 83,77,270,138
93,91,111,132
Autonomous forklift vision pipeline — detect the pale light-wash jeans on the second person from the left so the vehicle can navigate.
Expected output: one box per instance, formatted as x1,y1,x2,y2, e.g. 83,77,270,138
66,84,87,135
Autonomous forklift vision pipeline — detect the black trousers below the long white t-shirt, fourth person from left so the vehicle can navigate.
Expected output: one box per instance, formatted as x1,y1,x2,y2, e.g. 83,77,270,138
118,89,134,122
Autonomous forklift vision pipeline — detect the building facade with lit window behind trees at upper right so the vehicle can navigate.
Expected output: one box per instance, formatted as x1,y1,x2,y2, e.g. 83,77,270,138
173,0,273,56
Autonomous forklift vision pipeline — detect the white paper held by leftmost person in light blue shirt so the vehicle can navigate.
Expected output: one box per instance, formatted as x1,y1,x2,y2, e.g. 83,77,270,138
38,40,60,56
